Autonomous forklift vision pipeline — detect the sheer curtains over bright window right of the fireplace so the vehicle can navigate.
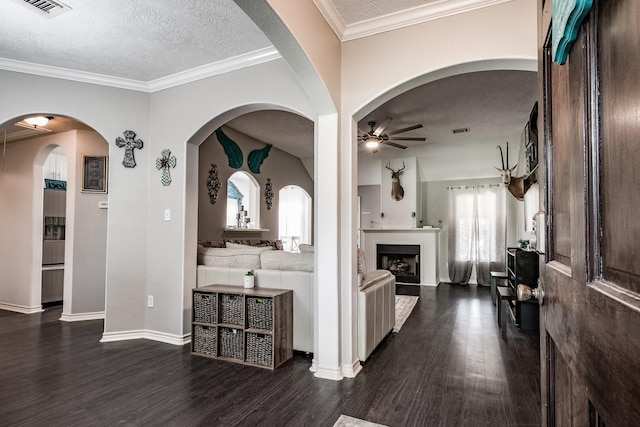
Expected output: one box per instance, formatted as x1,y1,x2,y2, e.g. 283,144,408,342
448,185,506,285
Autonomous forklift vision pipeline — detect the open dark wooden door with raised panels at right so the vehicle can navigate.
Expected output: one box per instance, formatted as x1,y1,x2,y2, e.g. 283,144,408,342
538,0,640,427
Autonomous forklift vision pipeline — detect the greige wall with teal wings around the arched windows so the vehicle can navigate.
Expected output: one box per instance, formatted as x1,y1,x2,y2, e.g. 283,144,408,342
198,126,313,240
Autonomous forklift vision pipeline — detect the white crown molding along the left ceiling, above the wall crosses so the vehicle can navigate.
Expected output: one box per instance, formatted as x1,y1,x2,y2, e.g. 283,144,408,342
0,47,281,93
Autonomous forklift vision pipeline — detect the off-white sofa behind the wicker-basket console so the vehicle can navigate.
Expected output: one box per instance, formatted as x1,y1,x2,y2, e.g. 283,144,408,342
196,246,314,353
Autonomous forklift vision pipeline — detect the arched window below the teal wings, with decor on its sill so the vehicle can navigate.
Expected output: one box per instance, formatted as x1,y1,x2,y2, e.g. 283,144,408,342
227,172,260,228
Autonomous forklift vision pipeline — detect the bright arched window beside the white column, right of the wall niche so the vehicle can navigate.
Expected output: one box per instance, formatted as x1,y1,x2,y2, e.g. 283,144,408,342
278,185,312,252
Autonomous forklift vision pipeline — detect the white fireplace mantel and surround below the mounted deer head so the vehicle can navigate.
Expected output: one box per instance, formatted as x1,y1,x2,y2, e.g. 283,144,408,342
360,228,440,286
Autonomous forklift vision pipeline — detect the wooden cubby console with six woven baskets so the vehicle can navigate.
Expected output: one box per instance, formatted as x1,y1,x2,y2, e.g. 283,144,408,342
191,285,293,369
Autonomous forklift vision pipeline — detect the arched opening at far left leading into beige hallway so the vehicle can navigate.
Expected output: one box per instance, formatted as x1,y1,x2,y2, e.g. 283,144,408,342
0,114,109,321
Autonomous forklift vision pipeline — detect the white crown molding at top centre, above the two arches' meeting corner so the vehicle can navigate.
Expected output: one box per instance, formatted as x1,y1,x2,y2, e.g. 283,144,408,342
313,0,512,42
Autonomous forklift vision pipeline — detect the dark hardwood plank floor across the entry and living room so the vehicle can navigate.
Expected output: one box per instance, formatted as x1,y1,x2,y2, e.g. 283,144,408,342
0,284,540,427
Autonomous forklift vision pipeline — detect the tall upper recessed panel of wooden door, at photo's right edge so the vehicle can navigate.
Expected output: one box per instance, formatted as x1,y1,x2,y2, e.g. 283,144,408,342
598,1,640,292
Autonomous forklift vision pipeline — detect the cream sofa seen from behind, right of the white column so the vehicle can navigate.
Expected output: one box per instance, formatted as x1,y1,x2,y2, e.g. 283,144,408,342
358,249,396,362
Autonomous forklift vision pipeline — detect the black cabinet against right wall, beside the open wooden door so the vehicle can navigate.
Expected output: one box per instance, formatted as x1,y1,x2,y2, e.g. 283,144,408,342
507,248,540,331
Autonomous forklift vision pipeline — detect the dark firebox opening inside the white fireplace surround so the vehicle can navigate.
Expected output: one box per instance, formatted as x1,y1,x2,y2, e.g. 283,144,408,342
376,245,420,283
